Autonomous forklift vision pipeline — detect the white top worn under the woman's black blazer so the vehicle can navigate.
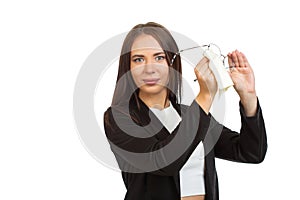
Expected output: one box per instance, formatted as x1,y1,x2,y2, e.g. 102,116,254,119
150,103,205,197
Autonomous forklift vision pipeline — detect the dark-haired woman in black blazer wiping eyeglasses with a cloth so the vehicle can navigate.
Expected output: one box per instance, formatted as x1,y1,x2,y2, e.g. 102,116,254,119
104,22,267,200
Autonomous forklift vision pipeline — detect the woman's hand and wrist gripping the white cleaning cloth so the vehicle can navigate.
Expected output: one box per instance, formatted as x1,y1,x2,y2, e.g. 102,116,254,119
194,57,218,113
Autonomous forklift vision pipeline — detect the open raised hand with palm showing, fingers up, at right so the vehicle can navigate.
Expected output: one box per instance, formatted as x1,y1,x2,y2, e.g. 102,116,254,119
227,50,257,116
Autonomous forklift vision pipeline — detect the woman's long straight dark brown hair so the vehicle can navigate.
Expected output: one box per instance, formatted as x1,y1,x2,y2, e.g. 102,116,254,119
112,22,182,109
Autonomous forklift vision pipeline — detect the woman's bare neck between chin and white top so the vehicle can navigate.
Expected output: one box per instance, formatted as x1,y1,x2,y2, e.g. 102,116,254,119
139,90,170,110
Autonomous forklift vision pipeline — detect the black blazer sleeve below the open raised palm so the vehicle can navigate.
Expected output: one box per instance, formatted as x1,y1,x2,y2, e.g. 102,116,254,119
214,97,267,163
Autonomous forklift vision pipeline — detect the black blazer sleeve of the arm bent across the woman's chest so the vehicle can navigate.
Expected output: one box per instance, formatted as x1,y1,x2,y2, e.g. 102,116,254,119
104,101,210,176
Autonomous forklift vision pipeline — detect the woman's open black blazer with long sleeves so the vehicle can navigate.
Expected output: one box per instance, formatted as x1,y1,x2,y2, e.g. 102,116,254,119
104,96,267,200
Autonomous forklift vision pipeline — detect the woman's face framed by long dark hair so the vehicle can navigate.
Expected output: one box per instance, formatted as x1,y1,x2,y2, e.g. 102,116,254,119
130,34,169,98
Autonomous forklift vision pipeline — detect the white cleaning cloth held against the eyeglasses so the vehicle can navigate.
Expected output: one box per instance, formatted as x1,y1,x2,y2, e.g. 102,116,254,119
197,49,233,92
